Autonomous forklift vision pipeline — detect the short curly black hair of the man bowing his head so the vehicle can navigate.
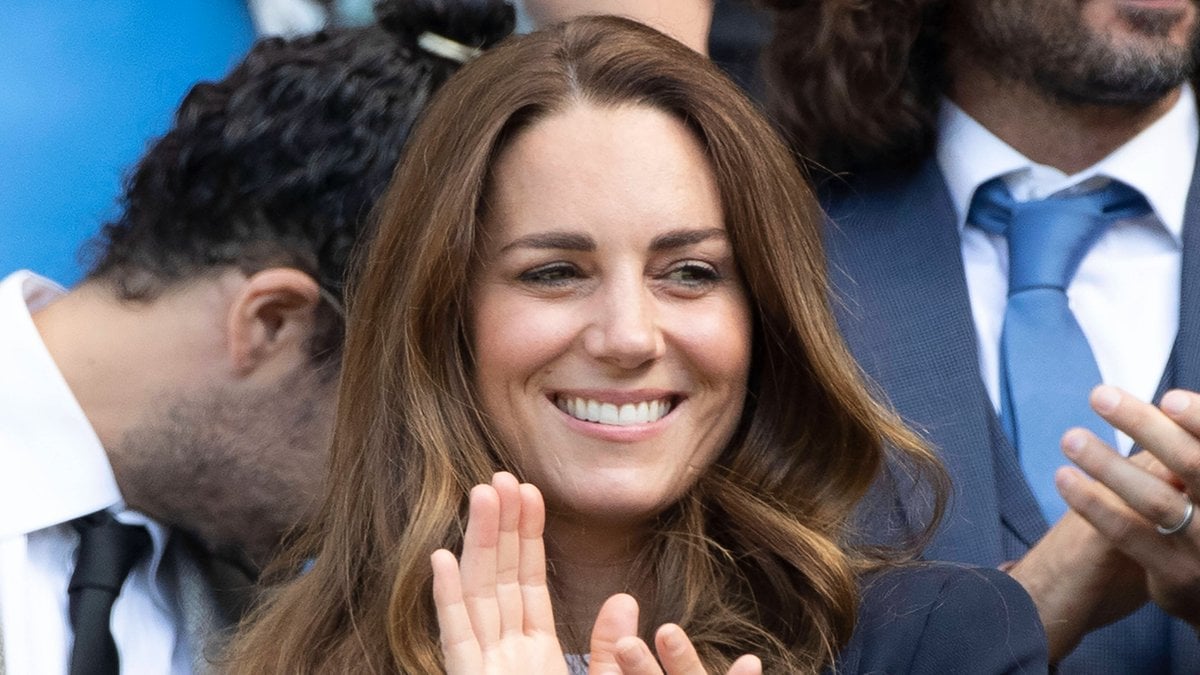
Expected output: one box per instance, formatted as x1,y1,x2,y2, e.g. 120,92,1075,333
86,0,515,360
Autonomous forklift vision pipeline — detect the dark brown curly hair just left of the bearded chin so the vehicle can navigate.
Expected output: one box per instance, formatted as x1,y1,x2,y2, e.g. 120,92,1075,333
758,0,947,175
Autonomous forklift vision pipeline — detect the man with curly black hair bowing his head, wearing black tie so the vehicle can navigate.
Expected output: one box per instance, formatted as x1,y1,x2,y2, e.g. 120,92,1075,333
0,0,514,675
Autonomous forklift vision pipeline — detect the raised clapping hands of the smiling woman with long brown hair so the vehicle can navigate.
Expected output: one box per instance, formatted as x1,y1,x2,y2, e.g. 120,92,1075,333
431,473,762,675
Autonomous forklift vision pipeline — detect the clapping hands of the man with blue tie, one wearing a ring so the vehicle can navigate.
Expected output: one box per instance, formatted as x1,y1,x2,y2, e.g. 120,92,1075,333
1010,386,1200,661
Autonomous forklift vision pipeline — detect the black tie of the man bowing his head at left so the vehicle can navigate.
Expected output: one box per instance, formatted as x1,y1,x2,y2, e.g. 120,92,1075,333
67,510,150,675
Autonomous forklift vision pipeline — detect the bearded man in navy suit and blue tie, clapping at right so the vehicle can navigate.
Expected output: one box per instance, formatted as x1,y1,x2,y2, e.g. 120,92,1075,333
763,0,1200,673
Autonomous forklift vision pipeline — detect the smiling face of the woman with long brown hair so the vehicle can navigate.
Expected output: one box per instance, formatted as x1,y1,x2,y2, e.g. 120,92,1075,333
470,103,751,524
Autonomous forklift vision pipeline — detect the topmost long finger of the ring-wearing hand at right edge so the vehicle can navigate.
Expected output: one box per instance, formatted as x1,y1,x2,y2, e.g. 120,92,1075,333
1090,384,1200,491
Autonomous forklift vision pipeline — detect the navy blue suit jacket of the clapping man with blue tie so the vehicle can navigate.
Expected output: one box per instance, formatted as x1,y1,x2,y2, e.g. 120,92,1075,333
826,159,1200,674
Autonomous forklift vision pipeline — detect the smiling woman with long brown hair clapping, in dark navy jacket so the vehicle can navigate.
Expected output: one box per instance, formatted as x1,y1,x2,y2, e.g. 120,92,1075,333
225,11,1045,675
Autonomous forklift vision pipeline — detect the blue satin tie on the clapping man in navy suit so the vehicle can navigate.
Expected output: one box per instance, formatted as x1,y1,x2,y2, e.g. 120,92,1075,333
967,178,1150,524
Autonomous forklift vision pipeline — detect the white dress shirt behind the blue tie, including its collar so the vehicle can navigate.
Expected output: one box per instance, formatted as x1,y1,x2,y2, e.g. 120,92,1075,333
937,85,1200,453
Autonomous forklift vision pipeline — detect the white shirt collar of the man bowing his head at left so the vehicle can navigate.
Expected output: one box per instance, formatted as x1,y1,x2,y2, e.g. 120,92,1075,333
0,271,168,593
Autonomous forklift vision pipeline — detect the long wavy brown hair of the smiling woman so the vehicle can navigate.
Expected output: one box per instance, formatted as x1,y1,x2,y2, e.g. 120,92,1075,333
223,17,942,675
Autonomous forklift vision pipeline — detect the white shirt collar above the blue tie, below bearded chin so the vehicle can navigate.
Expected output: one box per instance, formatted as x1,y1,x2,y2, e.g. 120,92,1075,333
937,84,1200,244
